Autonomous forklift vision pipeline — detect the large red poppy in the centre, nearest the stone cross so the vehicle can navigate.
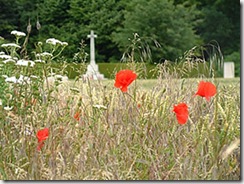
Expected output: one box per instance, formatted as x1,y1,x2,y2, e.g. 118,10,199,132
114,70,137,92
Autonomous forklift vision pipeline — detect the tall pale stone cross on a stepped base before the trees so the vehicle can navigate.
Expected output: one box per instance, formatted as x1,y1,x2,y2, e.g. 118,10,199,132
83,31,104,80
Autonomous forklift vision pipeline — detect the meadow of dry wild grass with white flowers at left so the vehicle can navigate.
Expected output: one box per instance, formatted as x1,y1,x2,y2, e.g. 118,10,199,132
0,31,240,180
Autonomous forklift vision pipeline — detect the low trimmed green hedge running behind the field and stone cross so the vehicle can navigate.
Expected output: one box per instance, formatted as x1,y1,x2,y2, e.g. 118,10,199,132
52,63,220,79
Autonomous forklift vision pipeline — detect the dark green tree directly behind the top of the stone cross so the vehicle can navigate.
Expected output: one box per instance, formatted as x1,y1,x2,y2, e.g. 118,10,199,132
68,0,123,62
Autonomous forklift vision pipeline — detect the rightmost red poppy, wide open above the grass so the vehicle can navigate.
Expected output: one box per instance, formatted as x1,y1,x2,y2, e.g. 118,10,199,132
195,81,216,101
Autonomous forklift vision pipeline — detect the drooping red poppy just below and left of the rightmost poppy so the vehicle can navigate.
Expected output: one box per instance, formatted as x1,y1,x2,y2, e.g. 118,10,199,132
173,103,189,125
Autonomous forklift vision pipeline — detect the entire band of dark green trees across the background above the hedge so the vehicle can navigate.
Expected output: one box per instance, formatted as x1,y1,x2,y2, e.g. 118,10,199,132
0,0,240,64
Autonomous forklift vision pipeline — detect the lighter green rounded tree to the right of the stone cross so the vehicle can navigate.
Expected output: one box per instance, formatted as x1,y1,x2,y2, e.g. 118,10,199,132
113,0,200,62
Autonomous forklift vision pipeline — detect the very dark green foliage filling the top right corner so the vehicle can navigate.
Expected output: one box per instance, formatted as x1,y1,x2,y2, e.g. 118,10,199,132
197,0,240,55
